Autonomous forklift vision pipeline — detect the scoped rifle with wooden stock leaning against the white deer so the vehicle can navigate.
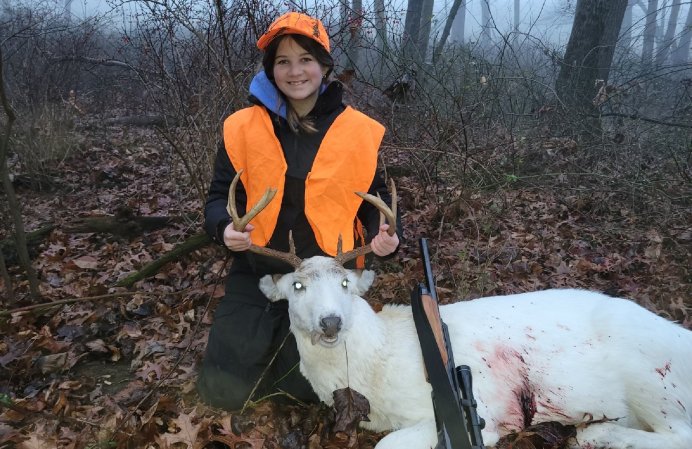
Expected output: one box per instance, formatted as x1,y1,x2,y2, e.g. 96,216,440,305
411,238,485,449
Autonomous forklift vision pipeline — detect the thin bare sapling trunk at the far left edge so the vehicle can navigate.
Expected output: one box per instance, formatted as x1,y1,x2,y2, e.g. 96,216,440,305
0,43,41,301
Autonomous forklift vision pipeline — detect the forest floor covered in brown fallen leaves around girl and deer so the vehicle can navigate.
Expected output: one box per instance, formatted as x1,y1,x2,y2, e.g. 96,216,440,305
0,116,692,449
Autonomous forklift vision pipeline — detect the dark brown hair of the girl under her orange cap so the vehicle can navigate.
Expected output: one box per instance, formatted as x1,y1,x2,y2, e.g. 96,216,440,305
262,34,334,133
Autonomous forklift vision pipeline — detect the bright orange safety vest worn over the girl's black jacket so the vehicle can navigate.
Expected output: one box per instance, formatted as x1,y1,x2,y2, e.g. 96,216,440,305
223,106,385,256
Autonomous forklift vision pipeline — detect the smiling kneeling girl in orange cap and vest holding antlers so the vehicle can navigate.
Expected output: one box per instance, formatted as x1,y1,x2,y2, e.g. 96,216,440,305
197,12,401,410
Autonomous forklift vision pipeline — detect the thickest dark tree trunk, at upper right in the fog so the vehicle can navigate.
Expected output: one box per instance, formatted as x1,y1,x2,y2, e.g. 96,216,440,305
555,0,627,121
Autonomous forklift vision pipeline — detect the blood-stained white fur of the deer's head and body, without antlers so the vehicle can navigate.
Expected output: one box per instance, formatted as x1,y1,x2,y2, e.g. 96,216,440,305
260,257,692,449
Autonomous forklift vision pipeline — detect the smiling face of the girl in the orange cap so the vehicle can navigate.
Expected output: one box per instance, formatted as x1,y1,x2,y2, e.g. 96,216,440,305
274,37,327,116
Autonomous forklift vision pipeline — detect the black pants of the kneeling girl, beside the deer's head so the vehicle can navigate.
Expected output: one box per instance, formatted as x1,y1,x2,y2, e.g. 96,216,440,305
197,273,319,410
